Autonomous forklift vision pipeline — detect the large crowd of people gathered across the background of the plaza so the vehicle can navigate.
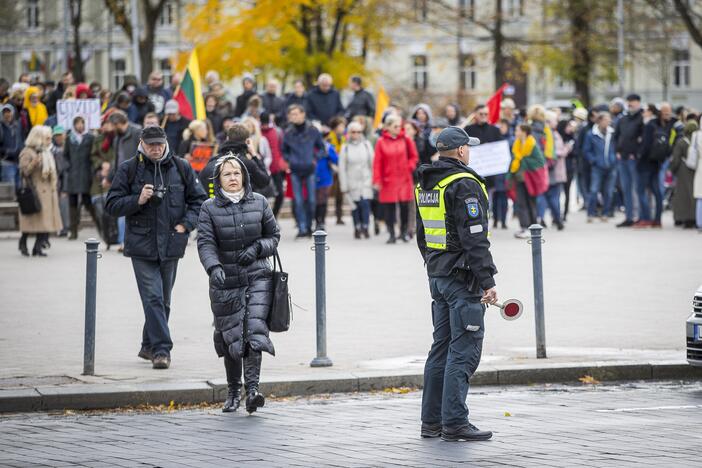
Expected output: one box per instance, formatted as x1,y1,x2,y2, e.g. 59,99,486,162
0,67,702,256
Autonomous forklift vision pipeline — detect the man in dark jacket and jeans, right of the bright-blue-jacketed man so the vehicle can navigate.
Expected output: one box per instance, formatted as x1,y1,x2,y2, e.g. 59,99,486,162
614,94,644,228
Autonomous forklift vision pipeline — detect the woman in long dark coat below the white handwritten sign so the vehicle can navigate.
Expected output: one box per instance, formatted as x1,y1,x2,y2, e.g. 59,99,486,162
63,116,98,240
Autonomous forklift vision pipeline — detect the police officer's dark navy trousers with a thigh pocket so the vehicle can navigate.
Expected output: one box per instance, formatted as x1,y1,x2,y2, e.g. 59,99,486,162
422,276,485,426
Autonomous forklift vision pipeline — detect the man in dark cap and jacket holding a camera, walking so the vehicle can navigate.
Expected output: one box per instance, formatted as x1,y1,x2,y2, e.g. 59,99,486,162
105,127,207,369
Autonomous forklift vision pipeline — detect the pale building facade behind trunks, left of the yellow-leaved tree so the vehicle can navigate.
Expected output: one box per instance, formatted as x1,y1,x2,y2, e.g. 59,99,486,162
0,0,190,89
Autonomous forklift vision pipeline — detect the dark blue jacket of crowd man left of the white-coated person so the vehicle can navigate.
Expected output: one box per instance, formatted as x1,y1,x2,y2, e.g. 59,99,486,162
283,122,327,177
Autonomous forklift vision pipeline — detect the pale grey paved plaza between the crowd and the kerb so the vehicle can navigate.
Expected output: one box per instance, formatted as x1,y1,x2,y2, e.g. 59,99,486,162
0,213,702,382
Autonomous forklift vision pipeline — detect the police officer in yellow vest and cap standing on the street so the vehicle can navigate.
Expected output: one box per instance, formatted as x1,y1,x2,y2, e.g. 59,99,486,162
415,127,497,441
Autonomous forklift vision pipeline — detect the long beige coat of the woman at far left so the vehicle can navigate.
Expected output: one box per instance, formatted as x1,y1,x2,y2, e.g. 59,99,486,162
19,146,63,234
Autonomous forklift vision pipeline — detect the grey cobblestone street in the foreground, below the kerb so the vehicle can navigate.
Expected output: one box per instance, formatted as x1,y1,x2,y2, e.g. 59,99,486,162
0,382,702,467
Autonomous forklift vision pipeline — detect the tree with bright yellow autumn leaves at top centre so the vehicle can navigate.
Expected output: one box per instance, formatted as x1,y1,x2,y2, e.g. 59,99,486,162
180,0,402,85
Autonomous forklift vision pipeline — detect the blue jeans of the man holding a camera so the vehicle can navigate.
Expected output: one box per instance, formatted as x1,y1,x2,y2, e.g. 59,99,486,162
132,258,178,356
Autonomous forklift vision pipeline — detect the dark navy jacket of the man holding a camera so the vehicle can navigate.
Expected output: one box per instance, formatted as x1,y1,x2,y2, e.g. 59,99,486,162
105,147,207,260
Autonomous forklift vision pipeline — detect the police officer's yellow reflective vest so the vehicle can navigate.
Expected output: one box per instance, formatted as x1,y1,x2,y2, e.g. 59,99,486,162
414,172,488,250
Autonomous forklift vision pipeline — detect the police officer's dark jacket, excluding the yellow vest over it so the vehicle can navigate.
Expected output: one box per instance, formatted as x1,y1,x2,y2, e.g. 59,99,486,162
417,158,497,293
